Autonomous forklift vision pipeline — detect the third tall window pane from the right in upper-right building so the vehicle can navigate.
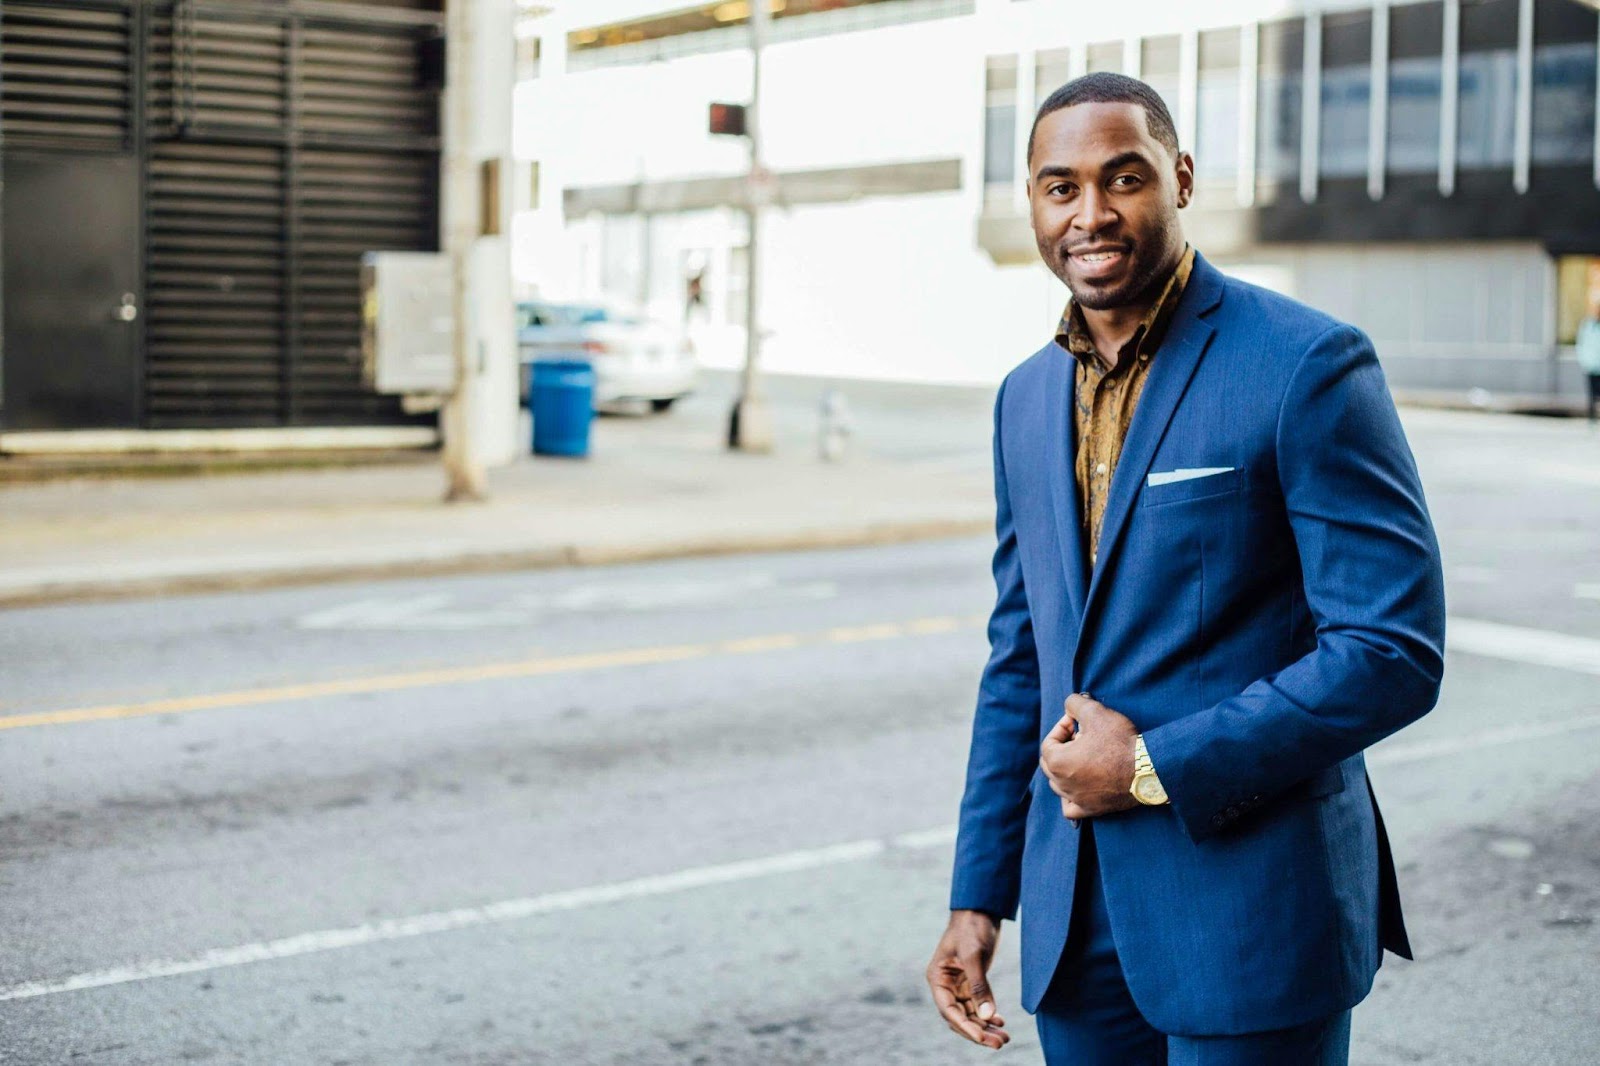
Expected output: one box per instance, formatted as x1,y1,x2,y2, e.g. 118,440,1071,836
1386,2,1445,174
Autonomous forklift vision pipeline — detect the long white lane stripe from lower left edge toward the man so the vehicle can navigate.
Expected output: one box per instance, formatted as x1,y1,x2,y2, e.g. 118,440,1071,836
0,828,934,1002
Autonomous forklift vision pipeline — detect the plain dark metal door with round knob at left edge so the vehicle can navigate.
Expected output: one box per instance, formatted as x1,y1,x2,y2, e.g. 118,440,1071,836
0,154,141,431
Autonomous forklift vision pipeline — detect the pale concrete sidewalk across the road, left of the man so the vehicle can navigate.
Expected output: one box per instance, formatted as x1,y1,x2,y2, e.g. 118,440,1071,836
0,375,994,607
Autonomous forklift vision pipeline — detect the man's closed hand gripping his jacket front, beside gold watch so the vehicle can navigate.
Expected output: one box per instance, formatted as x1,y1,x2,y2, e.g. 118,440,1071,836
1038,695,1139,818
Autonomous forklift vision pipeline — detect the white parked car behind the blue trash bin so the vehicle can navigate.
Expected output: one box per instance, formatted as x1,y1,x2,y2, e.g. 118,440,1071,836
517,299,699,411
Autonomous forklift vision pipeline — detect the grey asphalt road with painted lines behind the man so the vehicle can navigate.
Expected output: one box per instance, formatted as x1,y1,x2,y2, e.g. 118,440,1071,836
0,403,1600,1066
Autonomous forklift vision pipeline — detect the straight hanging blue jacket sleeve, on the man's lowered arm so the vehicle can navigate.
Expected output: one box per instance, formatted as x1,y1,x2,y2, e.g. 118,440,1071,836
950,372,1040,917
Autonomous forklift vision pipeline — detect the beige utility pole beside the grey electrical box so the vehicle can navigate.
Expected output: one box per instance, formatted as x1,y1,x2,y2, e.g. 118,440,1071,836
438,0,489,503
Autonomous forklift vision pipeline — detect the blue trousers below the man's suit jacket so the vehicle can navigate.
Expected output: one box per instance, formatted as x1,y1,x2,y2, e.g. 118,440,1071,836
1035,821,1350,1066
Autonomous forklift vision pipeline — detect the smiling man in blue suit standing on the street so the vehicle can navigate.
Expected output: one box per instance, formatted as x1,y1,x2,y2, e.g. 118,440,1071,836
928,74,1445,1066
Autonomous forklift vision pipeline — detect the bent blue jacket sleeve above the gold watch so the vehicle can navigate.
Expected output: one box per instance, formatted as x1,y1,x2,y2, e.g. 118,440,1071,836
1144,327,1445,840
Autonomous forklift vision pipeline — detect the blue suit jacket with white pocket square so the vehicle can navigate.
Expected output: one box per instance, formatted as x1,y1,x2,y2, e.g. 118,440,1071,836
950,249,1445,1036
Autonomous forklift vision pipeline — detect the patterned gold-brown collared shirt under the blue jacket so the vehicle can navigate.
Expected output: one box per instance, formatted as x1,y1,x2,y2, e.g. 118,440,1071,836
1056,246,1195,567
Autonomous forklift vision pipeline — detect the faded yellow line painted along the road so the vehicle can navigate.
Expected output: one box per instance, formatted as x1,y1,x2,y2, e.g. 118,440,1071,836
0,616,982,730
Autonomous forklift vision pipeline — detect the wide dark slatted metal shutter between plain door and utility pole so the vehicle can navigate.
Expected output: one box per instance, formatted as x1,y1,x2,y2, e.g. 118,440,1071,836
146,0,442,427
